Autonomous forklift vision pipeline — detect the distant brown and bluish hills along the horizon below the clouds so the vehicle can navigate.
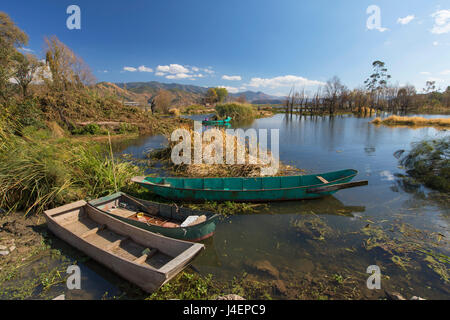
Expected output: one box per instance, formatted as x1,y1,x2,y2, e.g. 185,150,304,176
97,81,282,106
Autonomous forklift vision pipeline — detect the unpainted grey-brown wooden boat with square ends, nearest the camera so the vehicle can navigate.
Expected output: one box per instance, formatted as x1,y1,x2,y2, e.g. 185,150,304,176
45,200,204,292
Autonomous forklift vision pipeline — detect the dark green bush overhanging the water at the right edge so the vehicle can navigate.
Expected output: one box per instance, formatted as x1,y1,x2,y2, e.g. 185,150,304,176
401,136,450,192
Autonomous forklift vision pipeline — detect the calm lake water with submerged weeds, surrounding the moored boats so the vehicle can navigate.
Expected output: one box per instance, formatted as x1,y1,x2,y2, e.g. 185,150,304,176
110,114,450,299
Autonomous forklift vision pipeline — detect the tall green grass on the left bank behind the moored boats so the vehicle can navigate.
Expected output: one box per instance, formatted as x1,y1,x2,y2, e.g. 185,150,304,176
0,122,140,214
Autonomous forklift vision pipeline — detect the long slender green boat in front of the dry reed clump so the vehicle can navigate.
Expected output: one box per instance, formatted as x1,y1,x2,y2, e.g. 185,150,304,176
132,169,367,202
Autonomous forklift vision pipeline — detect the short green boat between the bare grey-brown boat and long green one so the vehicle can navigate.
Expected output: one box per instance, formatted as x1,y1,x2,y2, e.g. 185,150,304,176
88,192,219,241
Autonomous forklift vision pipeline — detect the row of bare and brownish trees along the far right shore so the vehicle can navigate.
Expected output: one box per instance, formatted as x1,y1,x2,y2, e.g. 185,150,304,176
285,60,450,114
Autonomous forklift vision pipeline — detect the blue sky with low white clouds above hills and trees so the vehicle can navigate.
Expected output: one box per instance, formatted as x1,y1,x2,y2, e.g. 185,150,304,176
0,0,450,95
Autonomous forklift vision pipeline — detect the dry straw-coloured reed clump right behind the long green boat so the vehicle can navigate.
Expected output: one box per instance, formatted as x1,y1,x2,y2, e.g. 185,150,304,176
149,126,299,177
